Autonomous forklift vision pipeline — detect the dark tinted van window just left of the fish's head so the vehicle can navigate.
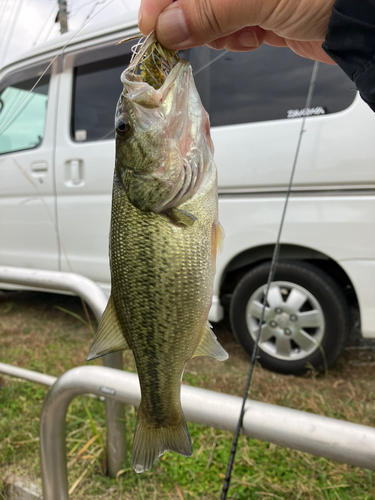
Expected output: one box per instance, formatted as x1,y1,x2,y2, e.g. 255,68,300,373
72,54,130,142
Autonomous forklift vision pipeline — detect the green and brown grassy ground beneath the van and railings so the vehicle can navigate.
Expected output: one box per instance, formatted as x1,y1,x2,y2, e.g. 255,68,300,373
0,292,375,500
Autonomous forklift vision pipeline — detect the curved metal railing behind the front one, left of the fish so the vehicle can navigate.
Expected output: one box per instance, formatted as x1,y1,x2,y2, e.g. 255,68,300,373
0,266,126,477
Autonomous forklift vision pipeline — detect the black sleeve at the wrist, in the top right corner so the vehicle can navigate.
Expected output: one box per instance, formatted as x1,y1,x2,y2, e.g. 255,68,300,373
323,0,375,111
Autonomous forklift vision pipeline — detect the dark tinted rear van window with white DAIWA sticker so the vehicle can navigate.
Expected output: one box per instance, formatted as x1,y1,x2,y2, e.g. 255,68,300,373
184,44,355,126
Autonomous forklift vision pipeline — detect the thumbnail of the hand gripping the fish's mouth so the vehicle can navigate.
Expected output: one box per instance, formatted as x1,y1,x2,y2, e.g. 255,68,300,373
156,4,190,47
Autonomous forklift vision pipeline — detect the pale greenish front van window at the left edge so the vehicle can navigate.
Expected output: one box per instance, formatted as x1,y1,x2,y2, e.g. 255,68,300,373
0,74,50,154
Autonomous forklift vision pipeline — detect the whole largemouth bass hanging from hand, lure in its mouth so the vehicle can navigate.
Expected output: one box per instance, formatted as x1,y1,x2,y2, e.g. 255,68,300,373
88,35,228,472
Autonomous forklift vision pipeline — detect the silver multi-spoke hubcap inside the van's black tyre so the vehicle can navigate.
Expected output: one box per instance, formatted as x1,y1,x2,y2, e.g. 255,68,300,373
246,281,325,361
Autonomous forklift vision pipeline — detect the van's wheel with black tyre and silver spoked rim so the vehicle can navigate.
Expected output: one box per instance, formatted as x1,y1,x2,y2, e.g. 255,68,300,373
230,261,350,374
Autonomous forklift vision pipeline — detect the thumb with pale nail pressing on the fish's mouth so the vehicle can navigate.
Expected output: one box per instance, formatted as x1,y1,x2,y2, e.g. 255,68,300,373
150,0,273,50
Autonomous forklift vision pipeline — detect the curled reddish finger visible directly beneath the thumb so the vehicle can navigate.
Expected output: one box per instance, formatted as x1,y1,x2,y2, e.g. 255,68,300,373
207,26,264,52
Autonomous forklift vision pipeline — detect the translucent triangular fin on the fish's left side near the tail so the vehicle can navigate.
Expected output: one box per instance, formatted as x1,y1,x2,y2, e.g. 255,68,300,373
87,296,130,361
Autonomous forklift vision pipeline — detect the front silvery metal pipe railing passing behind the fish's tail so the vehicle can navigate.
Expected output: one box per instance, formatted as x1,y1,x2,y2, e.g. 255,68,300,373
40,366,375,500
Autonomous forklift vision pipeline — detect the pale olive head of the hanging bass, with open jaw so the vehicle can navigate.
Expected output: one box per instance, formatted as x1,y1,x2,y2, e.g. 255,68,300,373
116,60,213,213
